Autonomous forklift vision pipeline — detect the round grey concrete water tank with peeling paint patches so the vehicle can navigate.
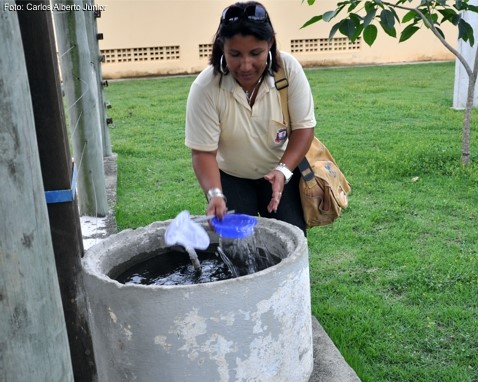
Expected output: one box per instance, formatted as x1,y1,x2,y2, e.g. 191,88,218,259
83,218,313,382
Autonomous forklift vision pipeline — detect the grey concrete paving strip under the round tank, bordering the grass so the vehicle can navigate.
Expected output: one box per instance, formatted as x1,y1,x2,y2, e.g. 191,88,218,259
80,156,360,382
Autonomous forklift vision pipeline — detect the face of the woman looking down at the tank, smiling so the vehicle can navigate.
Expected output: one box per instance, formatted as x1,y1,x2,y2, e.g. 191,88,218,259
224,34,272,90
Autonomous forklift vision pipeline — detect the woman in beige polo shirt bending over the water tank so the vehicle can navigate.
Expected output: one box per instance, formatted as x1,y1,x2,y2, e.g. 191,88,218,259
185,1,316,234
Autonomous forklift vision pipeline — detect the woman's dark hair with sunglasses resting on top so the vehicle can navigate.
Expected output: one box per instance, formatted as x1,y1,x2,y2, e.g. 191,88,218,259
209,1,279,74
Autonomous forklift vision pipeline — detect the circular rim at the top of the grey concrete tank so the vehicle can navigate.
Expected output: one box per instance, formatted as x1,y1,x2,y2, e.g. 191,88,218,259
82,217,308,290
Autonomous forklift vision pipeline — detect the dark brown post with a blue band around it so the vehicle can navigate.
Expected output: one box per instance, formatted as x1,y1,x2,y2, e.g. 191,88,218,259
16,0,97,382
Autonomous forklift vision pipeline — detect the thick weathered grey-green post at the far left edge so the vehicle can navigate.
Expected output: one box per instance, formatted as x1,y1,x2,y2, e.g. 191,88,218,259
0,0,73,382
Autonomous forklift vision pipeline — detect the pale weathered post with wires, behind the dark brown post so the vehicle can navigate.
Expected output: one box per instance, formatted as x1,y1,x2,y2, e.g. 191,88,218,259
54,0,108,216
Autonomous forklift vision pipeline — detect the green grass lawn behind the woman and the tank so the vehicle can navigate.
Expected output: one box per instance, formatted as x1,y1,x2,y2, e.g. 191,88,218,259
107,63,478,382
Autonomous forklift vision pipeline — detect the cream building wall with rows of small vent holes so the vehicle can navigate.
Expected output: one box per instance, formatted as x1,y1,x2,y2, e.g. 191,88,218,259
97,0,456,78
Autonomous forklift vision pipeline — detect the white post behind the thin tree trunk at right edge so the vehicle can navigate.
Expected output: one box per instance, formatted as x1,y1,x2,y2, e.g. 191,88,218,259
453,0,478,110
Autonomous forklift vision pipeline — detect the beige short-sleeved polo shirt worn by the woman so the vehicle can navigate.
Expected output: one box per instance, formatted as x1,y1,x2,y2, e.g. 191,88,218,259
185,52,316,179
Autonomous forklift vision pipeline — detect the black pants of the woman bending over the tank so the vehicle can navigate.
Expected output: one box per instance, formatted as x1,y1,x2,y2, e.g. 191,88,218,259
221,169,307,236
